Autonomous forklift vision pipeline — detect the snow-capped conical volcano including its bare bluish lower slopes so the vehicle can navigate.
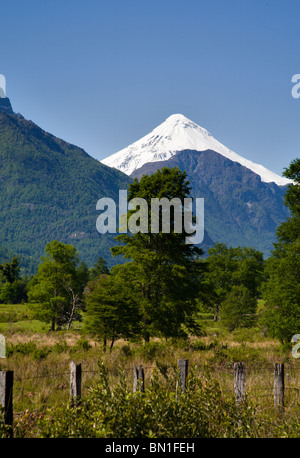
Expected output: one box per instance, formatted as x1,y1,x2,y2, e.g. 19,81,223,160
102,114,291,256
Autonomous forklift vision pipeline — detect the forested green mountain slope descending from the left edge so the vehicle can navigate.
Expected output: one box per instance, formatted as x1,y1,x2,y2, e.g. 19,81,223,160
0,99,132,272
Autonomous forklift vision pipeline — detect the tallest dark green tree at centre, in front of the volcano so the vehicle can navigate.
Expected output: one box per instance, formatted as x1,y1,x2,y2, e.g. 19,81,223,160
112,167,202,341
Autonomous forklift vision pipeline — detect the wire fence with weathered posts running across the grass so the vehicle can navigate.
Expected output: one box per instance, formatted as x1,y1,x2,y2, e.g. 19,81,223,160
0,359,300,436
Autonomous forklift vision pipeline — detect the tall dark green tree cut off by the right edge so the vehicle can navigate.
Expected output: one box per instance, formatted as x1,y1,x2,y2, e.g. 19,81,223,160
264,159,300,343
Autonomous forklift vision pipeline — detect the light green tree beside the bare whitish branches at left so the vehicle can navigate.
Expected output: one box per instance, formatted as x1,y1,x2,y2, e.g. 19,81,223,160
28,240,88,331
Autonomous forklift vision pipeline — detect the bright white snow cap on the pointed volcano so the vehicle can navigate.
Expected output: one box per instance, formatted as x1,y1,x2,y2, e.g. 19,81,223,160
101,114,291,186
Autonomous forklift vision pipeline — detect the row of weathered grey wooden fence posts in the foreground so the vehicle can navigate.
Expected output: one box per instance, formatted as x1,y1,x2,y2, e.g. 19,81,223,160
0,359,285,436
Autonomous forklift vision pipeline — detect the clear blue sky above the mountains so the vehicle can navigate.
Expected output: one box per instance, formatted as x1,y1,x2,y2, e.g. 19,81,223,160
0,0,300,175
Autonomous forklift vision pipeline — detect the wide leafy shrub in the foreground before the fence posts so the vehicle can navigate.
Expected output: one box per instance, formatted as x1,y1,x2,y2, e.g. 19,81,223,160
38,366,256,438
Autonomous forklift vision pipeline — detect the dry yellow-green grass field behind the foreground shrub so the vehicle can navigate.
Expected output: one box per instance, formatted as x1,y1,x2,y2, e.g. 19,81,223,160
0,304,300,437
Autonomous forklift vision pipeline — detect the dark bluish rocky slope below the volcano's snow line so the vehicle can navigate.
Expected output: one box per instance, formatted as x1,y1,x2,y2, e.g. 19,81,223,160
131,150,288,256
